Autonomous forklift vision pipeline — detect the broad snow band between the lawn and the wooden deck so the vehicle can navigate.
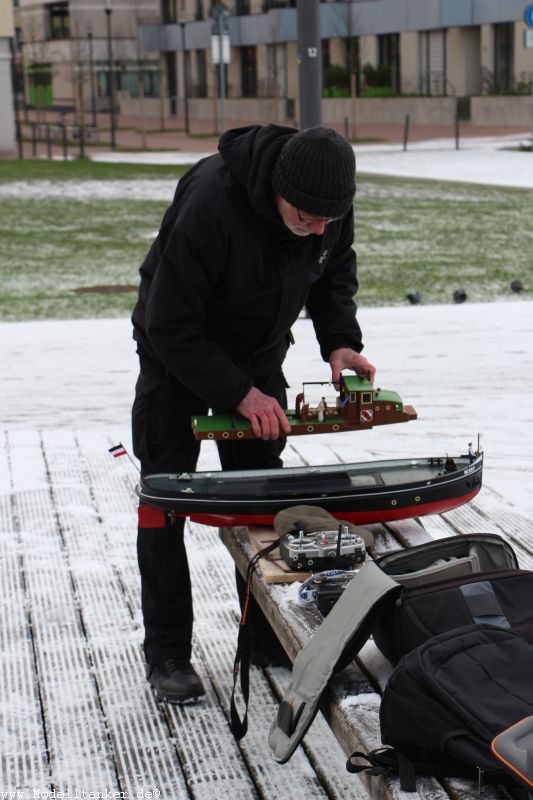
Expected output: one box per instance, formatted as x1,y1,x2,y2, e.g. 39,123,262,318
0,300,533,515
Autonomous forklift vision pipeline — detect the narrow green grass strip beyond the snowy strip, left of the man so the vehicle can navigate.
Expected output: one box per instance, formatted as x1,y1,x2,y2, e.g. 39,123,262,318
0,158,189,181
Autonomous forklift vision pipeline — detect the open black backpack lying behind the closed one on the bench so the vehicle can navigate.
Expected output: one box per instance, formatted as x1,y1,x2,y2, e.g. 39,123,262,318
372,533,533,664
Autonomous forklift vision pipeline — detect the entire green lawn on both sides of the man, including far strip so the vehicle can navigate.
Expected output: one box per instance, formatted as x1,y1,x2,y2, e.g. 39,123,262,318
0,161,533,320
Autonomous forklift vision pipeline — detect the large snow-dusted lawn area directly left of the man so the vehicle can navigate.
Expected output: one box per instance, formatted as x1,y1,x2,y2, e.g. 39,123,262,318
0,195,168,320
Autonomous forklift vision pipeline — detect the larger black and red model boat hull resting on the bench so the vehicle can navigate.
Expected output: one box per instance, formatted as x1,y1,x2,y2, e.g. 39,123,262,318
137,452,483,527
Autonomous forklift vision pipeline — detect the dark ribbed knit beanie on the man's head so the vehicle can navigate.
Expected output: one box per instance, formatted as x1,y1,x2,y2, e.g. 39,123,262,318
272,128,355,217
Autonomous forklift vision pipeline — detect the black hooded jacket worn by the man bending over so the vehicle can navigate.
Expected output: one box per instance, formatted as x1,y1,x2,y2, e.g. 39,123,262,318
132,125,362,409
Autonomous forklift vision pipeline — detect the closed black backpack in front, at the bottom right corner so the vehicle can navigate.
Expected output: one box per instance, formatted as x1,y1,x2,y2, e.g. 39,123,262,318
347,624,533,791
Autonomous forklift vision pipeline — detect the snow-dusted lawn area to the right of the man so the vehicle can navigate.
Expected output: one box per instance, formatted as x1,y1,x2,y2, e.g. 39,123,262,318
356,176,533,306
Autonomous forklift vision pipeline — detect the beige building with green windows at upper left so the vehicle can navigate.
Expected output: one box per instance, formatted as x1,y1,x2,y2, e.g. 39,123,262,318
17,0,161,119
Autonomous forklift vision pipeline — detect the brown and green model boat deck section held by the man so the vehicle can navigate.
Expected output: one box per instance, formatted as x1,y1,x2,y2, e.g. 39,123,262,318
191,375,417,439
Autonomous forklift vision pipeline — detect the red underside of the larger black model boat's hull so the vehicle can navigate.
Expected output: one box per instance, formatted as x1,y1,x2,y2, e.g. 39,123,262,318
185,489,479,528
